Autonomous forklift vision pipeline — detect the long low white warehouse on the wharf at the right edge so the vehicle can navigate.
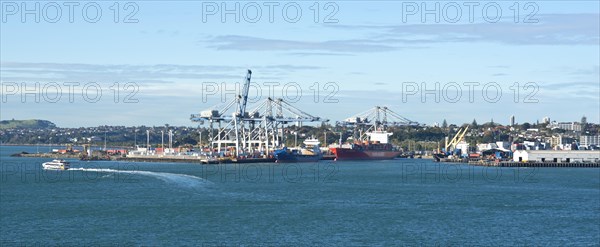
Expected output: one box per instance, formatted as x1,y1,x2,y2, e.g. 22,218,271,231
513,150,600,163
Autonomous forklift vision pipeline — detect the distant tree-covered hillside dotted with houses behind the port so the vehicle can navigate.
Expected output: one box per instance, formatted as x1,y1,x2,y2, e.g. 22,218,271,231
0,120,600,150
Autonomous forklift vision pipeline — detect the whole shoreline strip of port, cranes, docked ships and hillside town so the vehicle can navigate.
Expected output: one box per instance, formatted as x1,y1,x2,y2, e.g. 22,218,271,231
0,69,600,167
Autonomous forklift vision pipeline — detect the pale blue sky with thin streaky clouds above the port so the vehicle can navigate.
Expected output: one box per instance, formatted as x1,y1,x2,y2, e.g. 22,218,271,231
0,1,600,127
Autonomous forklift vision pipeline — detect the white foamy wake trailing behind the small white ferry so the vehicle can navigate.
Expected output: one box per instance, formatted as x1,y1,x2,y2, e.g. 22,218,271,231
69,168,211,188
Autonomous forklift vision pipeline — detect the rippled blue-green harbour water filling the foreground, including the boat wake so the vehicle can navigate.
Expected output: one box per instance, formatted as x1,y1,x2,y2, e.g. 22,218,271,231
0,146,600,246
